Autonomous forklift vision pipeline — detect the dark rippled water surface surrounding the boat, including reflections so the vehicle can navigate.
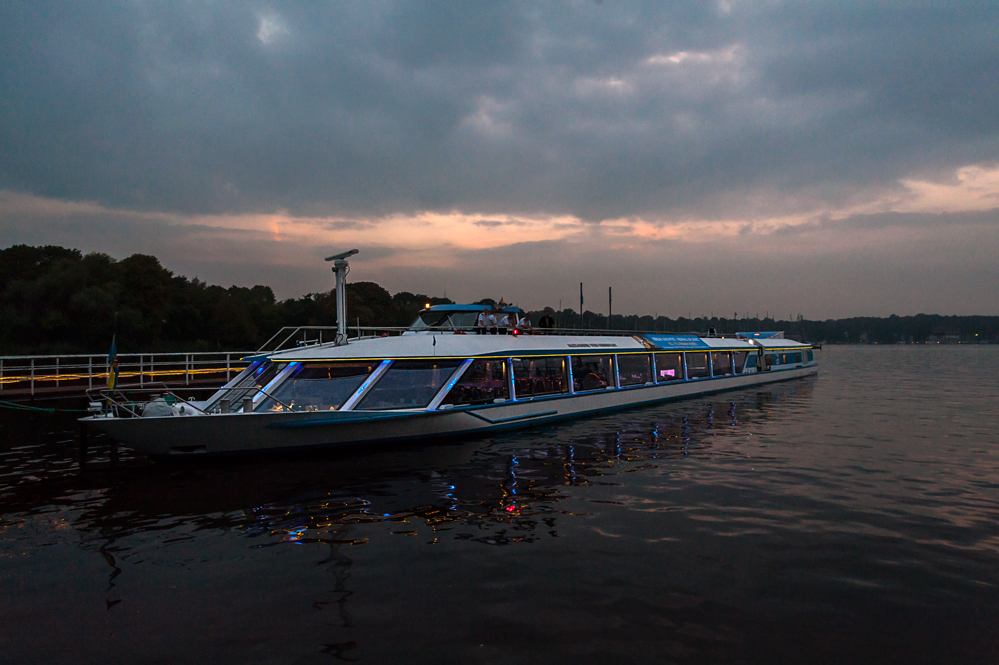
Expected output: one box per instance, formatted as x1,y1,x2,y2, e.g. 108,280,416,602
0,346,999,664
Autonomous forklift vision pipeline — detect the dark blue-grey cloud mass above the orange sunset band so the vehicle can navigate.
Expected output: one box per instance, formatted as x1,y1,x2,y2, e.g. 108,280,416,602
0,0,999,220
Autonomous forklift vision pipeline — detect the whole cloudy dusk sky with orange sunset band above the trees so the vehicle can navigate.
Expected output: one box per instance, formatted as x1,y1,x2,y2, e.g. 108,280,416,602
0,0,999,319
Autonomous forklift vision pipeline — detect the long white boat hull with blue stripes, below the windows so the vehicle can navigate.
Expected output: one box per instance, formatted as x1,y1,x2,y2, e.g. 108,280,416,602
82,363,818,457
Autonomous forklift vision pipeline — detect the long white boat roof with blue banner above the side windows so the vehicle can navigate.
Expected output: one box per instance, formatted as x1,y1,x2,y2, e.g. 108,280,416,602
254,331,809,362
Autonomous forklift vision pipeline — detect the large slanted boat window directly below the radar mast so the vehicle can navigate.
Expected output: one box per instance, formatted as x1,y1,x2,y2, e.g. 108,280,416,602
257,360,379,411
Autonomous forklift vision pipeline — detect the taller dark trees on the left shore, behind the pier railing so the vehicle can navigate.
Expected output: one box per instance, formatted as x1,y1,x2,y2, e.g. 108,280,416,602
0,245,451,355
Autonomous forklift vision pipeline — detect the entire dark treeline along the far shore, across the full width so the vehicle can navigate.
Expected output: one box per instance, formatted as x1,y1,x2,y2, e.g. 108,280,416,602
0,245,999,355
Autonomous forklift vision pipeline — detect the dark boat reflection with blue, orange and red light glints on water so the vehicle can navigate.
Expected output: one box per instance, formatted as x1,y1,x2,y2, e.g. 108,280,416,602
64,381,811,546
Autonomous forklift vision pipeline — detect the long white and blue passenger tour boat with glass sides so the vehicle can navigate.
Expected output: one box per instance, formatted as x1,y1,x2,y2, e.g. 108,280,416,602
82,250,818,457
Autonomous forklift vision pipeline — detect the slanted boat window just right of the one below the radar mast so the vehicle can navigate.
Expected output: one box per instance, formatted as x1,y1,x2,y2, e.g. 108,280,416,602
357,359,462,409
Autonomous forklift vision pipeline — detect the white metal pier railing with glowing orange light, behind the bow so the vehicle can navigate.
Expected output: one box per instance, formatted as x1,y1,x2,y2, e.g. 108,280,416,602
0,351,252,396
